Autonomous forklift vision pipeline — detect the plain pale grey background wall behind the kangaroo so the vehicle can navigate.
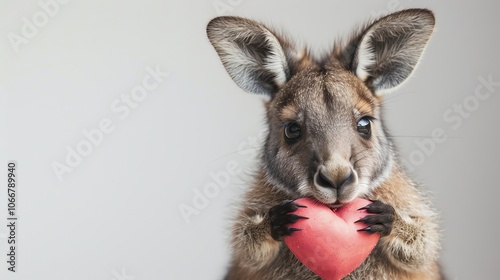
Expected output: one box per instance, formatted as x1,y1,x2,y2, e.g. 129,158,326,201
0,0,500,280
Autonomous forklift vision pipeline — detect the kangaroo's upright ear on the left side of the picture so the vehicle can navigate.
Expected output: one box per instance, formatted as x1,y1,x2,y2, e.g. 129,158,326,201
207,16,298,96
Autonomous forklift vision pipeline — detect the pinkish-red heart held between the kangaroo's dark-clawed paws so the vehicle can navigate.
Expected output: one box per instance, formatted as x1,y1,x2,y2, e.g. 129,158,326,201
285,198,380,280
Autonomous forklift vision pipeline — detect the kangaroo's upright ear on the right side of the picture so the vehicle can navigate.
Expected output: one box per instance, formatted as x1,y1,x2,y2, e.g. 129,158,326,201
352,9,435,95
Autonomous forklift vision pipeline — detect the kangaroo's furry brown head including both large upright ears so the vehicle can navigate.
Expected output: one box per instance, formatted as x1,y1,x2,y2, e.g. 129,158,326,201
207,9,434,206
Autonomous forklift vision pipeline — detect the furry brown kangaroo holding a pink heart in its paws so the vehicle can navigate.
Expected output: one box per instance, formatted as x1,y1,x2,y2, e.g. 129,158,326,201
207,9,443,280
